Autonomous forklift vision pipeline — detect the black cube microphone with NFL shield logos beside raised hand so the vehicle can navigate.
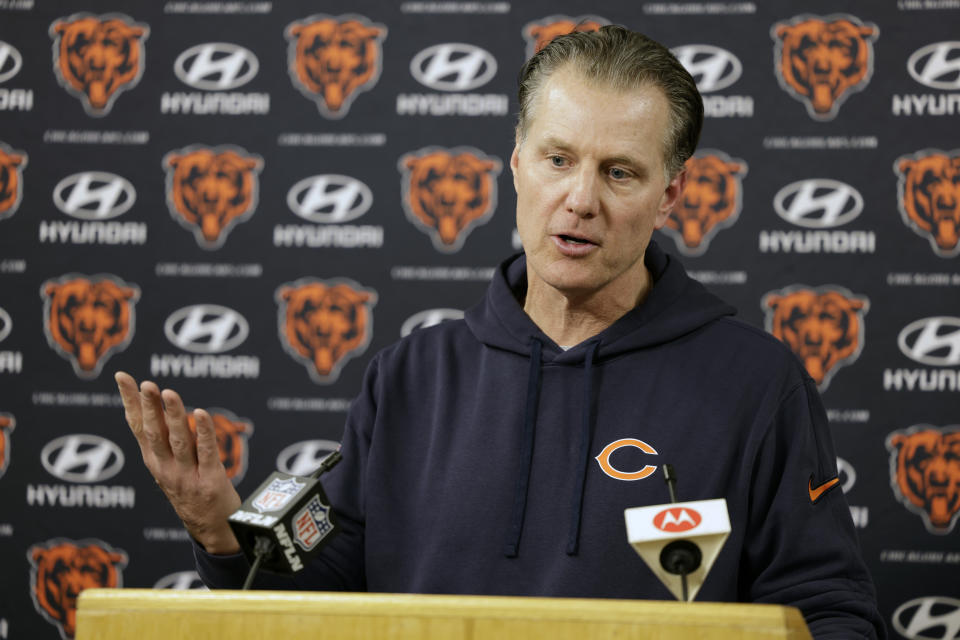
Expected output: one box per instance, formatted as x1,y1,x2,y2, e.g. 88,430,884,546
227,451,341,589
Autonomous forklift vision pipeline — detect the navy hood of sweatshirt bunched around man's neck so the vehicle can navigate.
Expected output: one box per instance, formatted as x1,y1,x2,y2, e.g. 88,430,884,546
465,241,736,364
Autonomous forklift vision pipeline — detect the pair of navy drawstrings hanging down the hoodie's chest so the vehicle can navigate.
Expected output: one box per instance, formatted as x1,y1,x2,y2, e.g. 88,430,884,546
504,338,600,558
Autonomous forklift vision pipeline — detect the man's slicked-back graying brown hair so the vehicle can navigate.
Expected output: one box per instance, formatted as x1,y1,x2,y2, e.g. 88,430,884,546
517,25,703,177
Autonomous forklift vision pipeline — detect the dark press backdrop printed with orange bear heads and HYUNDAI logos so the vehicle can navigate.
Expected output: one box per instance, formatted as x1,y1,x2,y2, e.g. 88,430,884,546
0,0,960,639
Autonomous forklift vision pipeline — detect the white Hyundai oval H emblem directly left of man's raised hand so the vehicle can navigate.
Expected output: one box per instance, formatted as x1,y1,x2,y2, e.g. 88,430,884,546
40,433,123,483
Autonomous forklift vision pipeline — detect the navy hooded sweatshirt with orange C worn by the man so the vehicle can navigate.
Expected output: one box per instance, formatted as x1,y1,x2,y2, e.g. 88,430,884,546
197,244,884,638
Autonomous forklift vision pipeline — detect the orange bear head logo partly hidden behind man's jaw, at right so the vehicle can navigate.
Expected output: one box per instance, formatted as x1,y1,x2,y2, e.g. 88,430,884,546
663,149,747,256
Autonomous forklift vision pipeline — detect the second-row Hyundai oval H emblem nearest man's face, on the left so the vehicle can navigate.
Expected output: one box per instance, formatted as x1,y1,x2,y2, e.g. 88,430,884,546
287,174,373,224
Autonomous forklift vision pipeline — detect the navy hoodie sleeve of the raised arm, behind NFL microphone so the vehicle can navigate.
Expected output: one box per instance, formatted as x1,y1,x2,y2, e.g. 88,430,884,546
193,357,379,591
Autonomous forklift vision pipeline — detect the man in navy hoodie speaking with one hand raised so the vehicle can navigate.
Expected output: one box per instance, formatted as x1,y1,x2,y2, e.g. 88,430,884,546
117,26,884,638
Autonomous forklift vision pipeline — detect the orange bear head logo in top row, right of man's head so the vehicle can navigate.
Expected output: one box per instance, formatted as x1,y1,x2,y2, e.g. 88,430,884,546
770,15,880,120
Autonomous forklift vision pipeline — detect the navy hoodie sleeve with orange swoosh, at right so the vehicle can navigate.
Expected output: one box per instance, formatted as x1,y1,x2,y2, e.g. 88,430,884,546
741,376,886,640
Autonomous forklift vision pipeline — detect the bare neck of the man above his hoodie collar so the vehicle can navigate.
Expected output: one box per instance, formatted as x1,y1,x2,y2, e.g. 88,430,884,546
523,267,653,346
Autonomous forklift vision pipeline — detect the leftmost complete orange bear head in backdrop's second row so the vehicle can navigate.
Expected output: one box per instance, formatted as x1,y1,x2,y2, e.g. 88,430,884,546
163,145,263,249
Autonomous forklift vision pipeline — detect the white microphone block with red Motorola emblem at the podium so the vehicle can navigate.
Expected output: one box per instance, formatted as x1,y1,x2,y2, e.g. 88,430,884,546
623,464,730,602
